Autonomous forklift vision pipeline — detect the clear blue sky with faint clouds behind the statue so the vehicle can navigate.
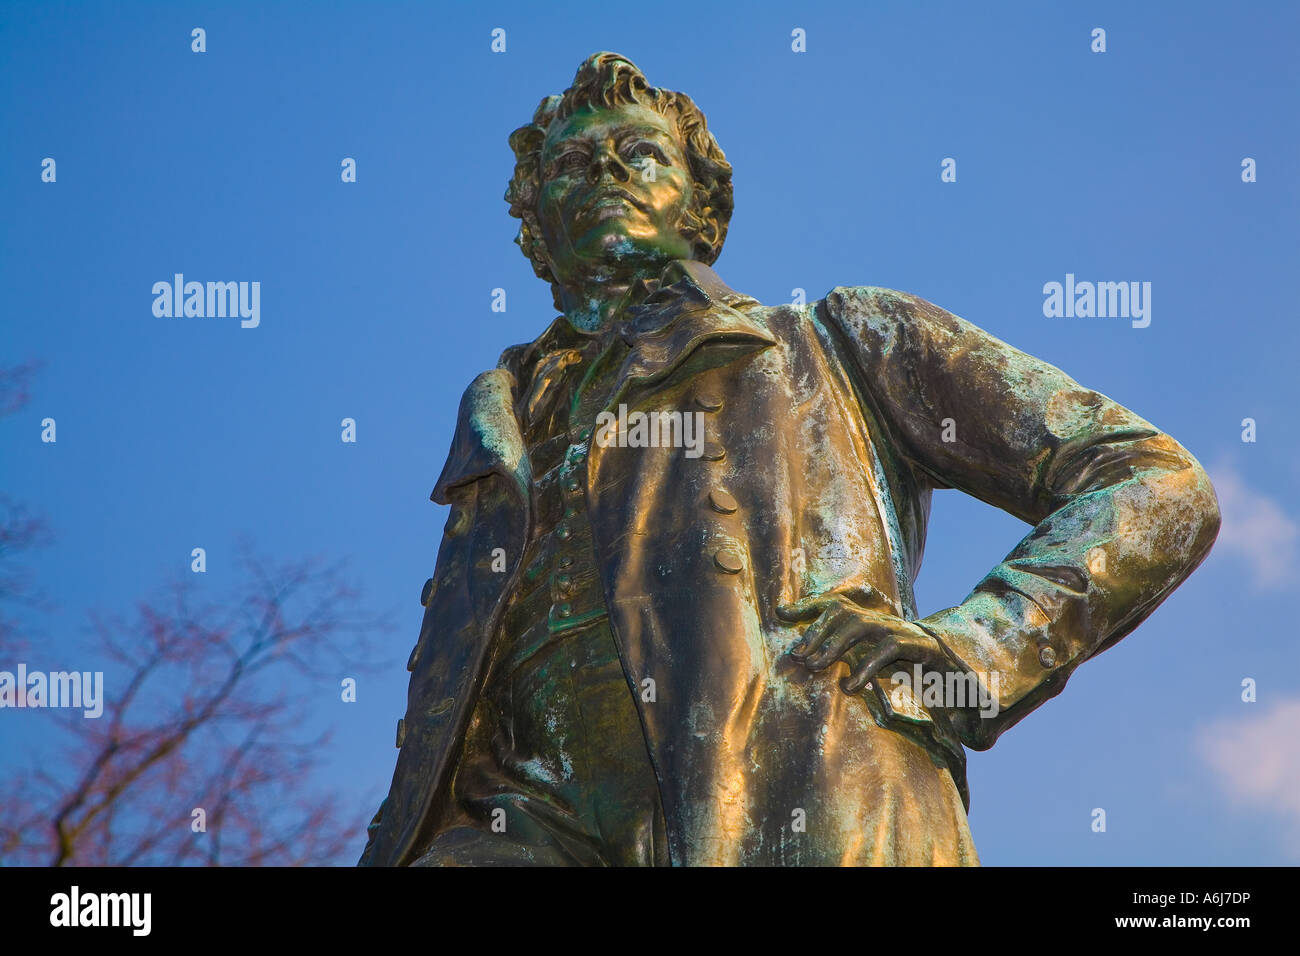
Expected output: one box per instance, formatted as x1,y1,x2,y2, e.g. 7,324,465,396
0,0,1300,865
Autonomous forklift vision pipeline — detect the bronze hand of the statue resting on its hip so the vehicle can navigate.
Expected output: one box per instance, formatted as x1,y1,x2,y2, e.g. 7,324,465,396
776,594,952,693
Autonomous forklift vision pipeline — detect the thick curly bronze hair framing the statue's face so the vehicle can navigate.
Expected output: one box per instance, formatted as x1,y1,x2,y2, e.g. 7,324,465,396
506,52,733,308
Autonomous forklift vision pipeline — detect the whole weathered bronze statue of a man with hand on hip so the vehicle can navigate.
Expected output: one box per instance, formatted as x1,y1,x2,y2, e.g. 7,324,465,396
361,53,1219,865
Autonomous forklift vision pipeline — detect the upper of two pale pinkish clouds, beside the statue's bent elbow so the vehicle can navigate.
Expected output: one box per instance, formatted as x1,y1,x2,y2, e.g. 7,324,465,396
1210,464,1300,591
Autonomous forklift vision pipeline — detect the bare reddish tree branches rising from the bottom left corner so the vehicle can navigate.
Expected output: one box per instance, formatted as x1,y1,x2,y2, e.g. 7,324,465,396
0,545,386,866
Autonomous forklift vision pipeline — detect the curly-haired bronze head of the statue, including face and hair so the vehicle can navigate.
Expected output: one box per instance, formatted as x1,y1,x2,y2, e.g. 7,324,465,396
506,53,732,308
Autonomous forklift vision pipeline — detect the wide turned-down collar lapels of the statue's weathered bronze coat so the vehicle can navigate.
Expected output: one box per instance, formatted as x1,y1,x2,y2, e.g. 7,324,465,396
430,259,776,505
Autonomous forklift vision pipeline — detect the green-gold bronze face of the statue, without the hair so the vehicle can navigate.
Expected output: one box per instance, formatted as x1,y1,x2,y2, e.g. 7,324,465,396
537,105,694,286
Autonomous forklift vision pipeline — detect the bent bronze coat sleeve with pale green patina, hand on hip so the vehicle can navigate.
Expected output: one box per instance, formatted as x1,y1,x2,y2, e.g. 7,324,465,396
823,286,1219,749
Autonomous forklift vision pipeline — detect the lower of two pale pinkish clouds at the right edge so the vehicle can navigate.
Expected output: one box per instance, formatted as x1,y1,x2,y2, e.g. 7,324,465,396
1196,698,1300,858
